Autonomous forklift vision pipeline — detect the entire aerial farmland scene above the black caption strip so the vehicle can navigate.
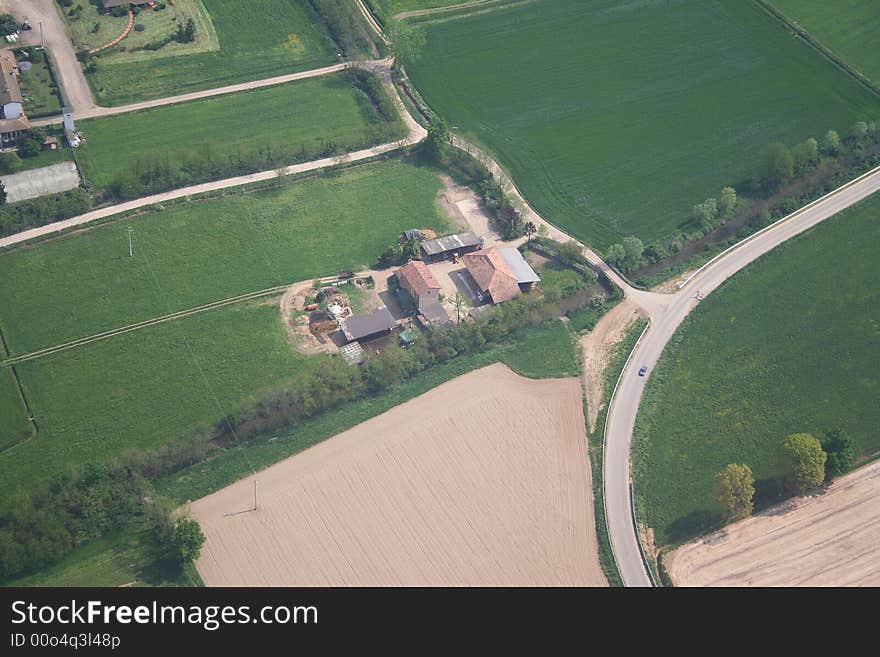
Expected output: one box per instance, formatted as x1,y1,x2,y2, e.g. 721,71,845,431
0,0,880,596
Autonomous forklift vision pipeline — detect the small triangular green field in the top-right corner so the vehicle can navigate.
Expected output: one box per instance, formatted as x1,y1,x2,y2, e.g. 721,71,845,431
770,0,880,84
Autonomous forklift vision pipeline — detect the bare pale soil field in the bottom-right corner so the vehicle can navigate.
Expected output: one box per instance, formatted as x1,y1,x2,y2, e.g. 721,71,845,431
666,461,880,586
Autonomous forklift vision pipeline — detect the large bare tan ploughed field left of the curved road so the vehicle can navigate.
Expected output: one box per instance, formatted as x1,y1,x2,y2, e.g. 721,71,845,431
192,364,606,586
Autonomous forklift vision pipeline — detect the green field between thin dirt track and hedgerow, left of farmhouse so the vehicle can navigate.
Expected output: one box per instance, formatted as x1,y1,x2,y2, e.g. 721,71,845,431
0,302,322,500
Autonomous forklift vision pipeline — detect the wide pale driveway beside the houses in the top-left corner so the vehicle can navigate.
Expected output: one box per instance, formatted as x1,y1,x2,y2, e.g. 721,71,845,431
0,0,97,114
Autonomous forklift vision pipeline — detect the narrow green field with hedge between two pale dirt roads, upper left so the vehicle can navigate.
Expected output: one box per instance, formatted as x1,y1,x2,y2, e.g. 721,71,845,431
78,74,405,189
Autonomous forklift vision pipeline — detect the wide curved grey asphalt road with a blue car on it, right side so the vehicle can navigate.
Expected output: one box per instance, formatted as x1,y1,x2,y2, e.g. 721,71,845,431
603,167,880,586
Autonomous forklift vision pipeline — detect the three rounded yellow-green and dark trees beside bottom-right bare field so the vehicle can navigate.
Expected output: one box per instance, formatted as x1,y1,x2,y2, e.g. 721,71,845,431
715,430,855,521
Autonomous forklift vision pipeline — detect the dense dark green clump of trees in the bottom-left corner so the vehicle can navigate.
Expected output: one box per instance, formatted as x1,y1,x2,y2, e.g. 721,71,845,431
0,464,204,580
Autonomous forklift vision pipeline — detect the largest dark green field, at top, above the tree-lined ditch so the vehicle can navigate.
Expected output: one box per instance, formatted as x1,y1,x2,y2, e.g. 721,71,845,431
407,0,880,248
